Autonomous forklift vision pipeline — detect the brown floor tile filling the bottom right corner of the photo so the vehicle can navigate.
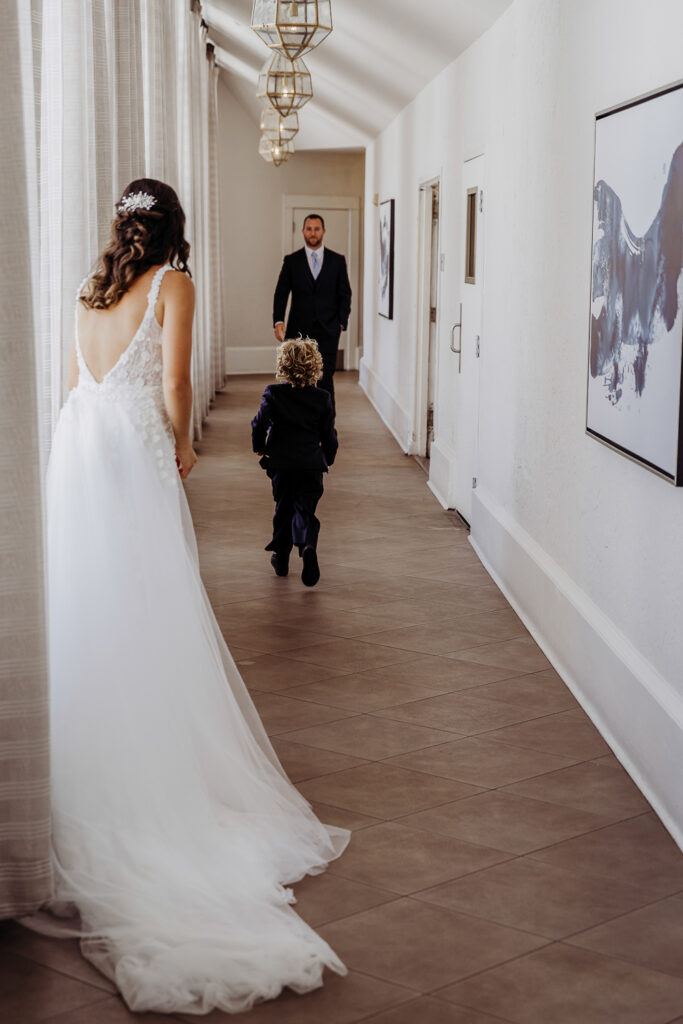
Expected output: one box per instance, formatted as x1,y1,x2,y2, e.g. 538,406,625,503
438,944,683,1024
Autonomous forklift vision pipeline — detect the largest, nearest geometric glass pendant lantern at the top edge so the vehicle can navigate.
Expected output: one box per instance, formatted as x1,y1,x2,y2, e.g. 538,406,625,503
251,0,332,60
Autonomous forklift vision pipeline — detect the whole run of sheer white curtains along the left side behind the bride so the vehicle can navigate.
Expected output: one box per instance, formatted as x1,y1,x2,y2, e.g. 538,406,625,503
0,0,224,916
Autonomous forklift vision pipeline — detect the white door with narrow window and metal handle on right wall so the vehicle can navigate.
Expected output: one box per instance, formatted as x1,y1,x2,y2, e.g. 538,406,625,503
451,157,484,523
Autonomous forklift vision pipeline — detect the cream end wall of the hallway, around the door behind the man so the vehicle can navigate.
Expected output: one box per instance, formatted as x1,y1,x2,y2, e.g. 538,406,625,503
218,80,365,374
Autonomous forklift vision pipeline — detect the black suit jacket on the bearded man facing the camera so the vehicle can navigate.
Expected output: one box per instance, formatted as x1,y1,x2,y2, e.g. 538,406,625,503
272,247,351,350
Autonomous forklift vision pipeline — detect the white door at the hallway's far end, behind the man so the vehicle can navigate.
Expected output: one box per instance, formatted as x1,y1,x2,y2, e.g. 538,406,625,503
285,196,360,370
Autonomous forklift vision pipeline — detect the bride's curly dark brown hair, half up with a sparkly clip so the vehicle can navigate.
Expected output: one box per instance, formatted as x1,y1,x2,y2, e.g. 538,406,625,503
80,178,191,309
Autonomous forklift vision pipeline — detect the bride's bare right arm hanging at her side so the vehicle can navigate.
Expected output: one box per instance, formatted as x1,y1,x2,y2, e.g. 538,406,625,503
159,270,197,479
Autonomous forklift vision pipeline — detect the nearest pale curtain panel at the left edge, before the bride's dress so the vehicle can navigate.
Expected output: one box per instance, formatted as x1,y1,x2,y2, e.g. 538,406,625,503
0,0,51,918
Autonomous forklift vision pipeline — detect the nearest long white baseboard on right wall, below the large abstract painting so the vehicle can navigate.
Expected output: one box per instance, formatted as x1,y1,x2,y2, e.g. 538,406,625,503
470,486,683,849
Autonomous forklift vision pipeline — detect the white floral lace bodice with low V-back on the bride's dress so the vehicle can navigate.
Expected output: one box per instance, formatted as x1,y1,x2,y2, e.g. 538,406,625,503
71,264,179,485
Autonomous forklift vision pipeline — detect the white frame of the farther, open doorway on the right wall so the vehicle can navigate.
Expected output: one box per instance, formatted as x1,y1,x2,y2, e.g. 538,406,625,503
413,174,443,456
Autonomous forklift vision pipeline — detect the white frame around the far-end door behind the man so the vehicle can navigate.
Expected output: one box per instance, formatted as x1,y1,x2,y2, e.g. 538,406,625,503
282,193,362,370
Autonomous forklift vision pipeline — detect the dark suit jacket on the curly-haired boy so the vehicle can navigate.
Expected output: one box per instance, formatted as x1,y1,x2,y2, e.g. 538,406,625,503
251,384,339,472
